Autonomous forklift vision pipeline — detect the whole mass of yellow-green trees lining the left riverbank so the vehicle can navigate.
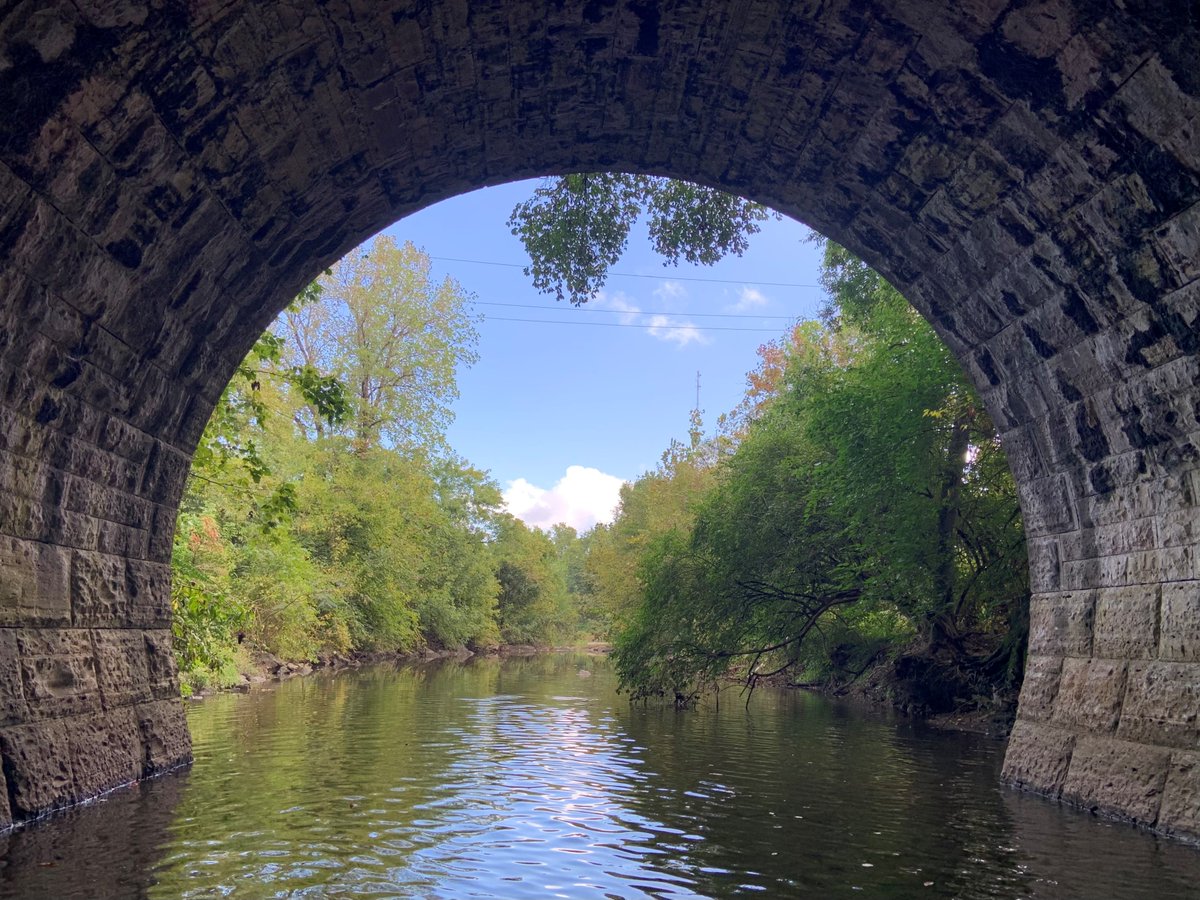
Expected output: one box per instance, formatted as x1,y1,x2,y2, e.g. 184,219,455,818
172,239,578,690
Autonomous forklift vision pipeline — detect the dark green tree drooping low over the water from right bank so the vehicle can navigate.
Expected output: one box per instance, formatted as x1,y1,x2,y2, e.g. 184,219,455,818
616,321,864,701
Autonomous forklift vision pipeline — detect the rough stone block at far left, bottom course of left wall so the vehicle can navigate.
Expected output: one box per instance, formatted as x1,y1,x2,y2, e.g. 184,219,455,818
0,721,77,818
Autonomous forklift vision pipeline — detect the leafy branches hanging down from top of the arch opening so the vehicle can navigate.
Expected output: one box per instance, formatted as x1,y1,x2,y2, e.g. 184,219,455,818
509,173,772,305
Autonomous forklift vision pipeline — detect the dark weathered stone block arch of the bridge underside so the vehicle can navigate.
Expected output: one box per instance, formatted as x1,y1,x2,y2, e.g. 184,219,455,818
0,0,1200,838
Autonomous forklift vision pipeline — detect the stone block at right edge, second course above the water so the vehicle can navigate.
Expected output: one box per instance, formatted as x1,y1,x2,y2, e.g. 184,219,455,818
1117,661,1200,750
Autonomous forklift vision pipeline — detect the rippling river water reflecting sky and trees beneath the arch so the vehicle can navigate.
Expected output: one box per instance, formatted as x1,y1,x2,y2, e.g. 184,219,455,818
0,655,1200,900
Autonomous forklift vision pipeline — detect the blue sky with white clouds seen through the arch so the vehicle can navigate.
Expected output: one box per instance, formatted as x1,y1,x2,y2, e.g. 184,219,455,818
386,181,822,528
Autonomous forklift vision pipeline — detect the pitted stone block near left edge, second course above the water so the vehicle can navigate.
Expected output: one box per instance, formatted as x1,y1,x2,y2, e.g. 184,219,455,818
17,629,101,720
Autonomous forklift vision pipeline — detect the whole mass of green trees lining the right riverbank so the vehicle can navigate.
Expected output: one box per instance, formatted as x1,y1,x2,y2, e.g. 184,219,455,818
614,245,1028,700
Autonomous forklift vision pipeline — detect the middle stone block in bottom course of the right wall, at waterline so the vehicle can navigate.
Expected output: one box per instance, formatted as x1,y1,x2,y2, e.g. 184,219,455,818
1062,736,1171,826
